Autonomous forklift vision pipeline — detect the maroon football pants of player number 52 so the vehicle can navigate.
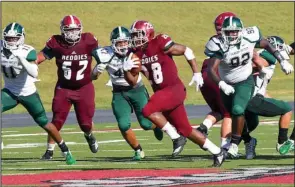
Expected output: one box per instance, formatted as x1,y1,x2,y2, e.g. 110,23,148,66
52,83,95,133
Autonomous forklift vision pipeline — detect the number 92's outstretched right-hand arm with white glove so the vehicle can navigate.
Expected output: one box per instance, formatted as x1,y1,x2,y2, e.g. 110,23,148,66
259,38,294,74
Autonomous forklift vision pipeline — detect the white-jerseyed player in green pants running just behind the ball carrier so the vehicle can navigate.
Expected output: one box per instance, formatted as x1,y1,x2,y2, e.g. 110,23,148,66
92,26,163,160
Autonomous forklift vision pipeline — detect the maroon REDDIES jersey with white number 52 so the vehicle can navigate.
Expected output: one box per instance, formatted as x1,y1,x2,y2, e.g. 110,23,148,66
42,33,98,89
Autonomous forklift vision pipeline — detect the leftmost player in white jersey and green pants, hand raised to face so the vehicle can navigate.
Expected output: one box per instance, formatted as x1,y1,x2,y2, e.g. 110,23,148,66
0,22,76,165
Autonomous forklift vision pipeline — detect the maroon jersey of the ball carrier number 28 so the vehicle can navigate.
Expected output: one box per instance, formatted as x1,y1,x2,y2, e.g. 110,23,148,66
135,34,182,91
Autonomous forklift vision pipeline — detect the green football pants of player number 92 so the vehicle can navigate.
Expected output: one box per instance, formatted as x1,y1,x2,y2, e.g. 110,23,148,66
220,75,255,116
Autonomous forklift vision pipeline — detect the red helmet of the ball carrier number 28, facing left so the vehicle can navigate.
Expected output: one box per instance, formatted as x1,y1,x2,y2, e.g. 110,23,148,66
130,20,155,48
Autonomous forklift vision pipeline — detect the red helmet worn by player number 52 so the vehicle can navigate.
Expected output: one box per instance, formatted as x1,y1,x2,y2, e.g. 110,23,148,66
60,15,82,45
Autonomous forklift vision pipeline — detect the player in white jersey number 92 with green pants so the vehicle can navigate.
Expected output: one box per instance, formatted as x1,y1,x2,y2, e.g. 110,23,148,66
205,16,294,156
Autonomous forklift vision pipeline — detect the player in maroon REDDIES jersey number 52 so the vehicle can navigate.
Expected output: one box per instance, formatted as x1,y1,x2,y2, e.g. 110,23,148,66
37,15,98,160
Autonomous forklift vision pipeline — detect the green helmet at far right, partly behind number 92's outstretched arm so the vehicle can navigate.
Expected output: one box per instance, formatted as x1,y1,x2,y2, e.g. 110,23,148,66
266,36,290,59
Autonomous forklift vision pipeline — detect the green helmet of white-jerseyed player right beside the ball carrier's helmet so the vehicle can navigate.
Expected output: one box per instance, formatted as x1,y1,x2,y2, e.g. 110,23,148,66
110,26,131,56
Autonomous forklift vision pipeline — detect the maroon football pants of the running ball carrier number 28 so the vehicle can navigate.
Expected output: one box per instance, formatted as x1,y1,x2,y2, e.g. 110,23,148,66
142,84,192,137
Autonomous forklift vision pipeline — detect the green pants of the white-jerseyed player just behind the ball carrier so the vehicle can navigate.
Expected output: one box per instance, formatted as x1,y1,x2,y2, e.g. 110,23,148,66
112,86,152,132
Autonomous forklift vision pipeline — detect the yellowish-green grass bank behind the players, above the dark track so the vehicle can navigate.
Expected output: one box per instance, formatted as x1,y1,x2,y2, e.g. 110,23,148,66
2,2,294,113
